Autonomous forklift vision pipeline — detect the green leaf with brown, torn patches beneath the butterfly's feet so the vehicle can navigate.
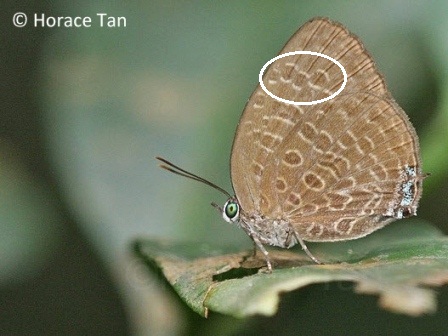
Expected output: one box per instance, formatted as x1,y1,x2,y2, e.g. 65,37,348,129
134,220,448,317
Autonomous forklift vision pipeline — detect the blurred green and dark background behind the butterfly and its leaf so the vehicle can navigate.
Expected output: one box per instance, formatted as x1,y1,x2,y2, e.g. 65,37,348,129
0,1,448,335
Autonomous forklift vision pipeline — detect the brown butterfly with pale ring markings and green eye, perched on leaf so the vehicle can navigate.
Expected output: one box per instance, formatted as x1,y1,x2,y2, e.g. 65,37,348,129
157,18,426,272
